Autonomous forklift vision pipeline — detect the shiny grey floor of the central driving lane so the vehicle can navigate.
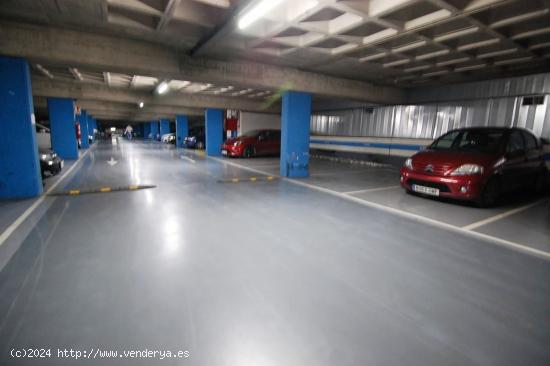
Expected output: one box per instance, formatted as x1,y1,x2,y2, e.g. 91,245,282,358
0,142,550,366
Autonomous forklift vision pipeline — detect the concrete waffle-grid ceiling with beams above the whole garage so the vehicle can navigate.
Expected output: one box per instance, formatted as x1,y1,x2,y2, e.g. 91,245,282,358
0,0,550,123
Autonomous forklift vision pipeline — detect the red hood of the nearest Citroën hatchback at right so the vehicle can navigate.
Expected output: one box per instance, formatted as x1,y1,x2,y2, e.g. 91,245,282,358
412,150,497,168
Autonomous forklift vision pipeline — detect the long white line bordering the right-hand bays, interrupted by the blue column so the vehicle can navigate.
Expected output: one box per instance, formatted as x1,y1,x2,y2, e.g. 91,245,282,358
216,157,550,260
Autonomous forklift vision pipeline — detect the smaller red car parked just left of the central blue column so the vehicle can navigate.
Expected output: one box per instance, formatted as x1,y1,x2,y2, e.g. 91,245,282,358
222,130,281,158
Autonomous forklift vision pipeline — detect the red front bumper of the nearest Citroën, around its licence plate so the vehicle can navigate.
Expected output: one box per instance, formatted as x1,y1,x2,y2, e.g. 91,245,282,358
400,168,485,201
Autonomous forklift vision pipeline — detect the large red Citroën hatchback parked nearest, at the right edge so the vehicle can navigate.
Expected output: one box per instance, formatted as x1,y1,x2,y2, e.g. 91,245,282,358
401,128,547,207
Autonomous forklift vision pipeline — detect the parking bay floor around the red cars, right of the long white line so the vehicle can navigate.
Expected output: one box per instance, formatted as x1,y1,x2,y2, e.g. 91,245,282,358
224,158,550,255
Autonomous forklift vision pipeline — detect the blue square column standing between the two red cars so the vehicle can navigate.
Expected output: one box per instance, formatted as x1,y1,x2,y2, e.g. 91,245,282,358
280,91,311,178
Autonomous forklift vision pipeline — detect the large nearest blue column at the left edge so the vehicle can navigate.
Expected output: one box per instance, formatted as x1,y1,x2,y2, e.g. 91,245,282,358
0,56,42,198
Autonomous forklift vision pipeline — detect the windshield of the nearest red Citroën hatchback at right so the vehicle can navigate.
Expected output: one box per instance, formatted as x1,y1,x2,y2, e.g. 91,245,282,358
429,129,504,153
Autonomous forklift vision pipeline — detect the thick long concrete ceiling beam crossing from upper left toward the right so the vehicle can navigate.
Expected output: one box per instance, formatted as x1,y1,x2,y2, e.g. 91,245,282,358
0,21,405,103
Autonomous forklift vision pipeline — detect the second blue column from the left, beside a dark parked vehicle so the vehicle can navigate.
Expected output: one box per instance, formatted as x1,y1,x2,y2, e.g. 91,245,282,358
48,98,78,160
